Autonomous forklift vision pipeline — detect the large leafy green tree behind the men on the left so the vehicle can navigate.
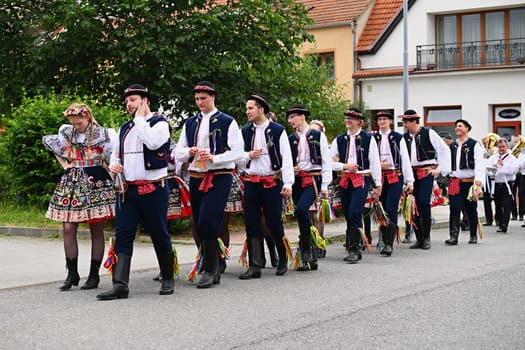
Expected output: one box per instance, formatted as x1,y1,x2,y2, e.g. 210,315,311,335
0,0,318,120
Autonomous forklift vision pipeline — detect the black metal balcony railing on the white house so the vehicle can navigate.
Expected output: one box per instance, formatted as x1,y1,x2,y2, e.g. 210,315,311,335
417,38,525,70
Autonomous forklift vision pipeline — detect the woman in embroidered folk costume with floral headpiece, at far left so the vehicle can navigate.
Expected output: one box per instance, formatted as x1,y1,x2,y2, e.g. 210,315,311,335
43,103,116,290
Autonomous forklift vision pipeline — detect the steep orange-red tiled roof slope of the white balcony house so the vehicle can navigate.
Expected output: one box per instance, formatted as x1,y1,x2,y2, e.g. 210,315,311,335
356,0,403,51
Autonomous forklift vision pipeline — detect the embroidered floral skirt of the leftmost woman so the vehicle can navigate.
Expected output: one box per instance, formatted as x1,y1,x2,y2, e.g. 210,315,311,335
46,166,115,223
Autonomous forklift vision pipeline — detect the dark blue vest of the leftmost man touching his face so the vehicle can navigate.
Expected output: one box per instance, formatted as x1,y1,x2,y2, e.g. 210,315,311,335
119,112,170,170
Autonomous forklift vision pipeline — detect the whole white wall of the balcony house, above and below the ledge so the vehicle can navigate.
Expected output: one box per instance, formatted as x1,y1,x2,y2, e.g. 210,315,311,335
359,0,525,139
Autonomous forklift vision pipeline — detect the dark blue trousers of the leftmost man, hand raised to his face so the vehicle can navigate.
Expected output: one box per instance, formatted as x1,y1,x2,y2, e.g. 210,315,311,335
115,181,172,256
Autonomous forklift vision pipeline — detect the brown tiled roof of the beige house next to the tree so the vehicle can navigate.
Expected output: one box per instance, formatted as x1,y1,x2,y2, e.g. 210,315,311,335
297,0,371,25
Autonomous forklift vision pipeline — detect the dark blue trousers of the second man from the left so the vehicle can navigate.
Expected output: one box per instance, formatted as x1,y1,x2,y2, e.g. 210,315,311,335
190,174,229,242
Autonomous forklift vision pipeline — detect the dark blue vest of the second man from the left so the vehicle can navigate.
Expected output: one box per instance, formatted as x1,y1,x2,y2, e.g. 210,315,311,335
186,111,233,162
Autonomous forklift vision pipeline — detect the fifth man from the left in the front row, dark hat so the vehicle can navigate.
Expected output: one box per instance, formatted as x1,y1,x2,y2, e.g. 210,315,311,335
330,108,381,264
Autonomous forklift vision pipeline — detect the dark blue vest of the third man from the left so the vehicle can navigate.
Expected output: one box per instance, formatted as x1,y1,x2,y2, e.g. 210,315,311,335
241,122,284,171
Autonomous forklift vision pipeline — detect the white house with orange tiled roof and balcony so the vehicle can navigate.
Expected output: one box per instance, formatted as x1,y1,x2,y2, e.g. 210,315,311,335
353,0,525,139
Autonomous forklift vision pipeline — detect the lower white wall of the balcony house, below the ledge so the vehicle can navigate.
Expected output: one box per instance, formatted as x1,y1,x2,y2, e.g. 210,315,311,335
362,69,525,139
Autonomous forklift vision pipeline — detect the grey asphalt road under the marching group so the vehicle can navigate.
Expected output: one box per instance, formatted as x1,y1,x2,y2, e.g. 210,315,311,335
0,222,525,350
